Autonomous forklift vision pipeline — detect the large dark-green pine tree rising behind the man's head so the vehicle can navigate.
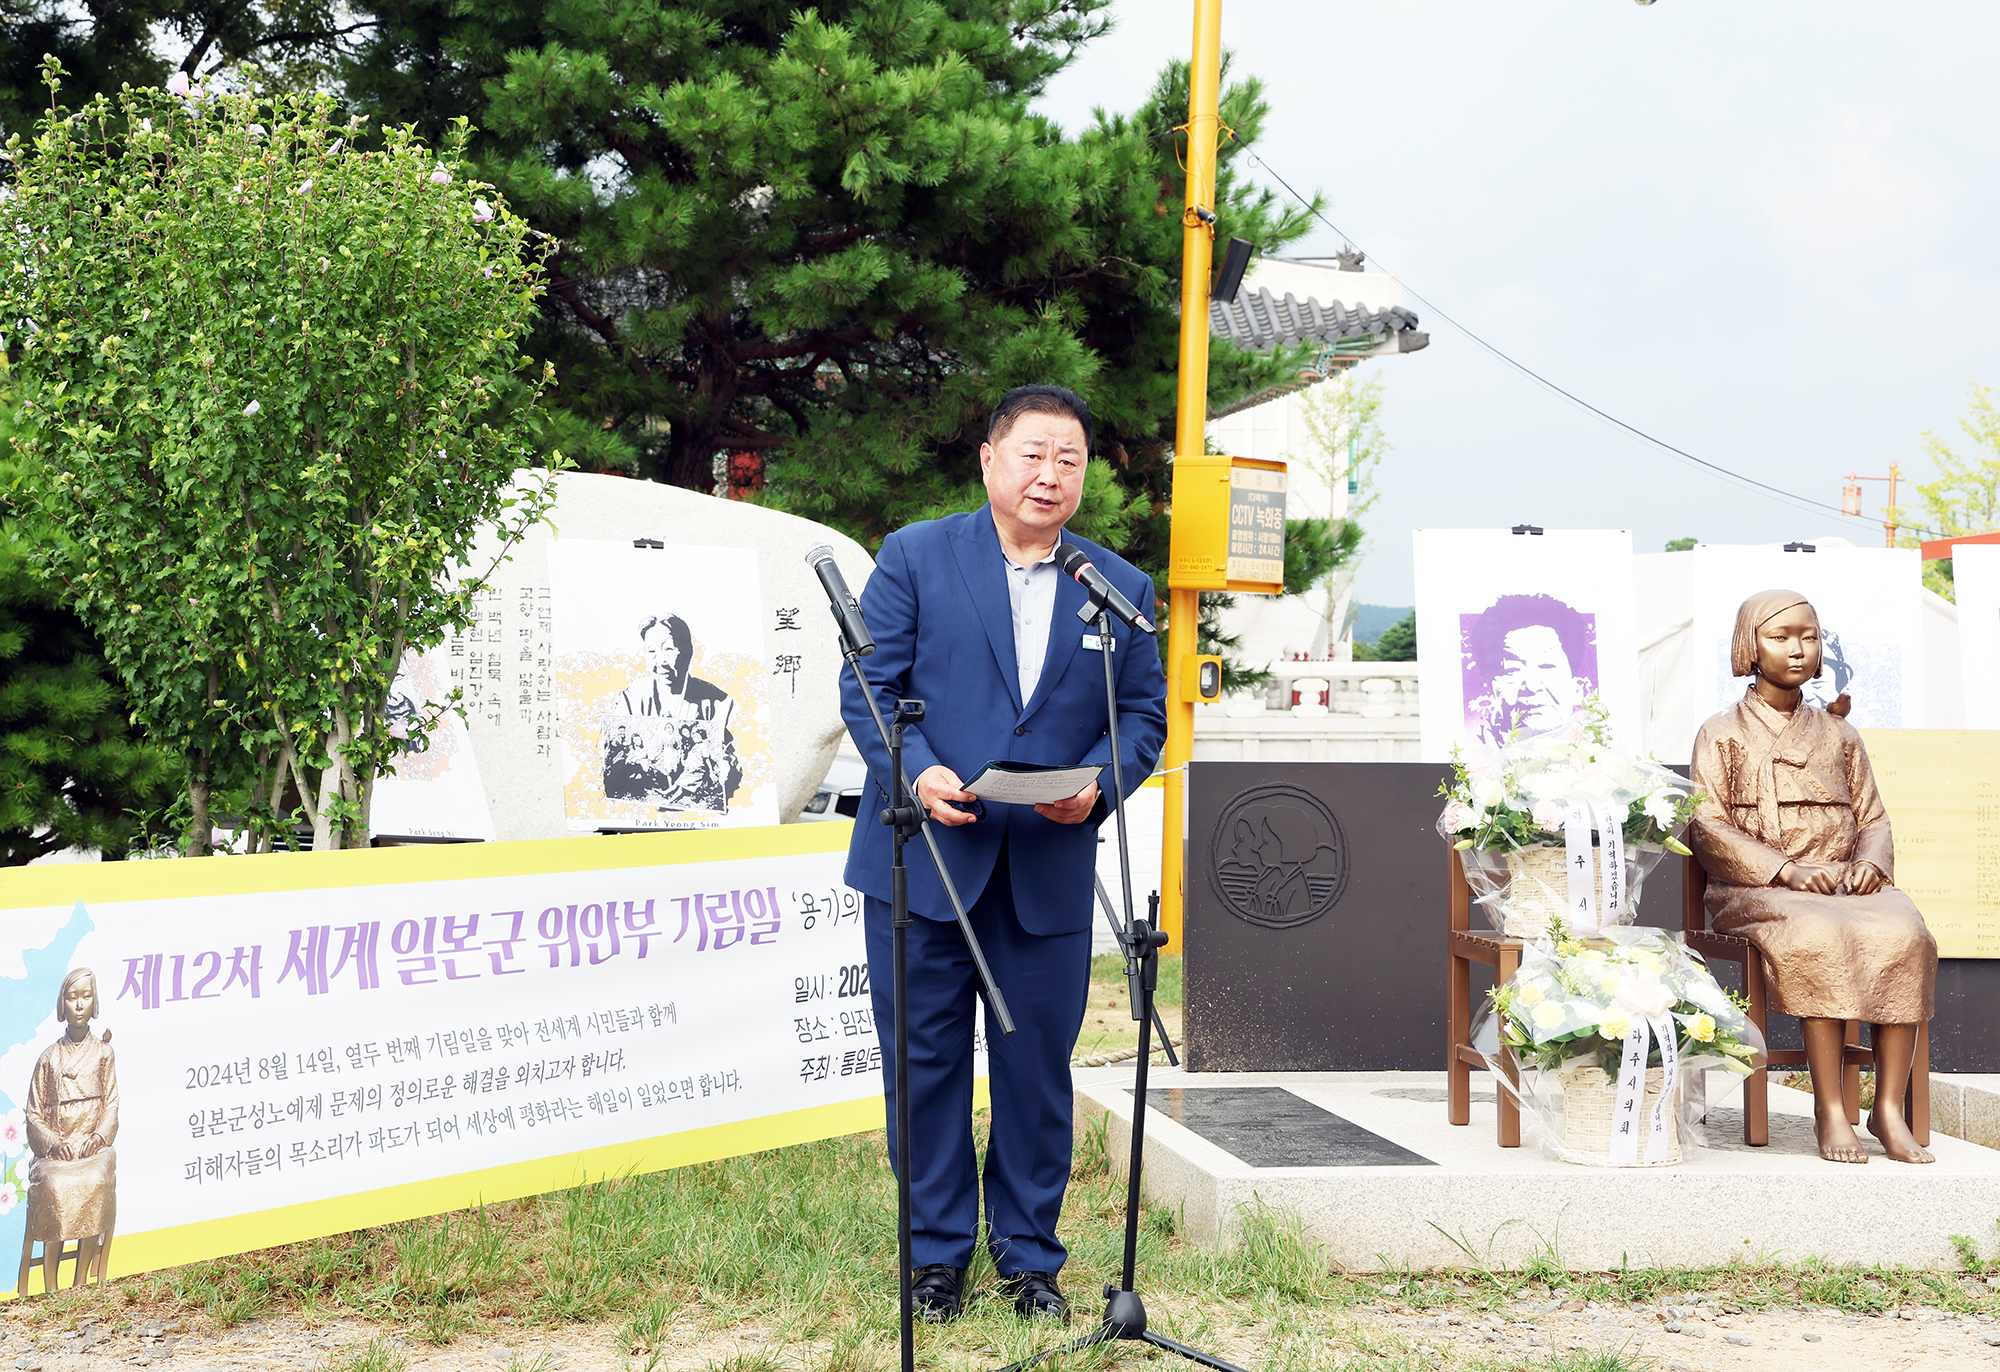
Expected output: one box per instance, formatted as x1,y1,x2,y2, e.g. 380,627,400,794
348,0,1304,568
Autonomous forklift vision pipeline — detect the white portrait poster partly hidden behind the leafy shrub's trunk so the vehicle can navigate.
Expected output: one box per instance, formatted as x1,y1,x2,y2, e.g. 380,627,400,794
368,644,496,842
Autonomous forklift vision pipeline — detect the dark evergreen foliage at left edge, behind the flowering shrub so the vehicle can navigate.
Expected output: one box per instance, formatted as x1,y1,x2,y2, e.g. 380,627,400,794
0,394,178,866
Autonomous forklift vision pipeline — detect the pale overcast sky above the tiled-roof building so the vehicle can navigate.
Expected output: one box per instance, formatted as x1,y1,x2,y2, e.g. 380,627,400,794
1040,0,2000,604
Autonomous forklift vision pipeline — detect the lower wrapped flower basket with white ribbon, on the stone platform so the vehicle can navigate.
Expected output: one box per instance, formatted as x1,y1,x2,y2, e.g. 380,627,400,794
1472,924,1764,1166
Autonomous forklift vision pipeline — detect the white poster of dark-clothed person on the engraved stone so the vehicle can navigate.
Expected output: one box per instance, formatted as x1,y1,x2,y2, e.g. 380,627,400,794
548,538,778,834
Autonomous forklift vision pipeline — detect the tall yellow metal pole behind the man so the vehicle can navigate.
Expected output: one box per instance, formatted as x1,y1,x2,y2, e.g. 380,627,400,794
1160,0,1222,952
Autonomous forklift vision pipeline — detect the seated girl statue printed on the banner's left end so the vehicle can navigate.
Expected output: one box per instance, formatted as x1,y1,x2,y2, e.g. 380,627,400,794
14,968,118,1296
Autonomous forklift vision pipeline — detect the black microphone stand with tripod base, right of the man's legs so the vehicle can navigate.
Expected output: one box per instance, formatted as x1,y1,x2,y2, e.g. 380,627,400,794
1000,608,1246,1372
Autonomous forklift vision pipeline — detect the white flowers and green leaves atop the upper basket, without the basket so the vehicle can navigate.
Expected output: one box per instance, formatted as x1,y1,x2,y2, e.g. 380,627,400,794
1438,696,1702,856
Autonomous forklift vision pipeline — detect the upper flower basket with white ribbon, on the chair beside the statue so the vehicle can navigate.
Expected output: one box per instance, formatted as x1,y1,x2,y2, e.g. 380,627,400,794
1438,696,1700,940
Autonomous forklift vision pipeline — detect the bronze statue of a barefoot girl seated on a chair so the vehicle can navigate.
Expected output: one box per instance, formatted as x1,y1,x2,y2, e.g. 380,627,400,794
1688,590,1938,1162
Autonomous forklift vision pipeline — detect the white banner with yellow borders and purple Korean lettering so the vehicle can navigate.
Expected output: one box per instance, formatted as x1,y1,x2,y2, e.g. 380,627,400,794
0,824,972,1294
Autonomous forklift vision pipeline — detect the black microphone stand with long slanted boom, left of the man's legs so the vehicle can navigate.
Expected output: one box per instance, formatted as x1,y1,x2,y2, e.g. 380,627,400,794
834,604,1014,1372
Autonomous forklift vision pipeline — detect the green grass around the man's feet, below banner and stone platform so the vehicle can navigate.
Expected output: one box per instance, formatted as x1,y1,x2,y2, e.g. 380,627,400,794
8,1130,2000,1372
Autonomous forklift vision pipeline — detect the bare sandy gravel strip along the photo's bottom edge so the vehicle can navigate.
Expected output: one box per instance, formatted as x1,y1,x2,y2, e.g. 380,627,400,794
11,1298,2000,1372
